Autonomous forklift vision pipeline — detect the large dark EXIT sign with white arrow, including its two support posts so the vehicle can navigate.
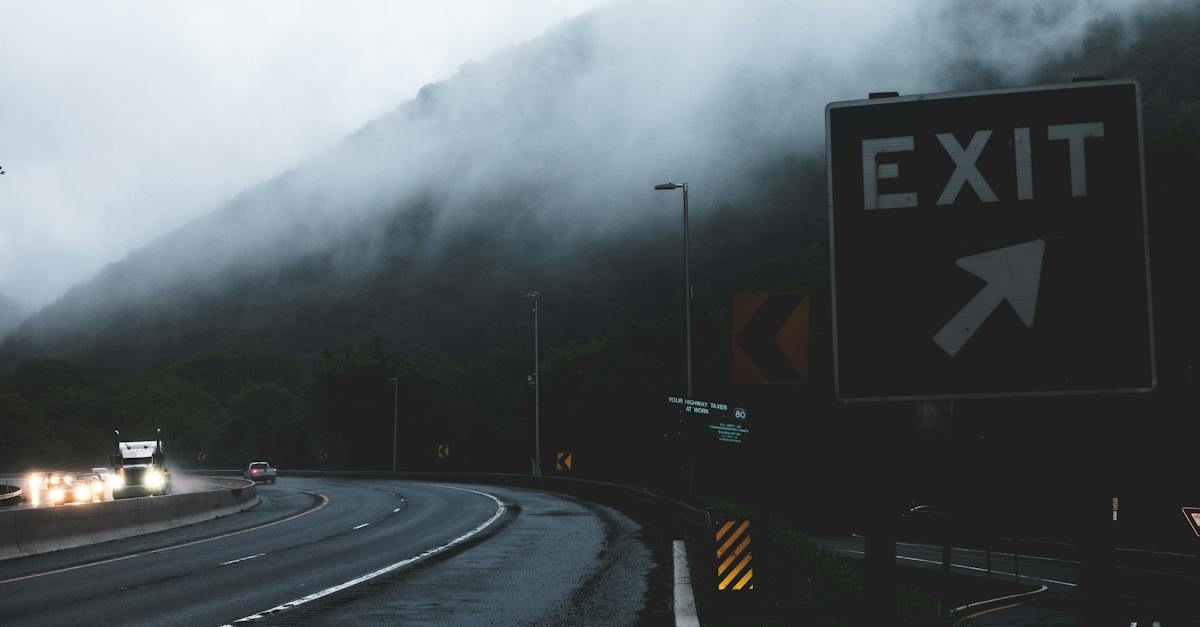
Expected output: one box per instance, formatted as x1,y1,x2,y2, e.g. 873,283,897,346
826,80,1157,615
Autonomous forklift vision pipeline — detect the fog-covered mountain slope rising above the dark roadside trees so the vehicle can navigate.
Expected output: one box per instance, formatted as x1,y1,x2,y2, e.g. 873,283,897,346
0,0,1200,384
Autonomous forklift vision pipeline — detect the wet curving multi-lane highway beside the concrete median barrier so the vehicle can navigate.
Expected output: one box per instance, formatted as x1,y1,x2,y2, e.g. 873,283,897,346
0,478,671,625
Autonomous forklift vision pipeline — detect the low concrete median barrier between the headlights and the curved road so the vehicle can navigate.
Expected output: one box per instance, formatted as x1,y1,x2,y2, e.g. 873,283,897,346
0,477,258,560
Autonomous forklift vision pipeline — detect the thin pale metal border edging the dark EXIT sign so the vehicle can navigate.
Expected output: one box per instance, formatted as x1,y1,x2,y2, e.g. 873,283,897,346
824,79,1158,404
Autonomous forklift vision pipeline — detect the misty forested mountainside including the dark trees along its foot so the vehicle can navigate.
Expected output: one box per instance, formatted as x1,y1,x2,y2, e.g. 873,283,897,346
0,2,1200,521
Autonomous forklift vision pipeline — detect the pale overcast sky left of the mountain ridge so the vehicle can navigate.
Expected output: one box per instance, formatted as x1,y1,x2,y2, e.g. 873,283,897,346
0,0,605,309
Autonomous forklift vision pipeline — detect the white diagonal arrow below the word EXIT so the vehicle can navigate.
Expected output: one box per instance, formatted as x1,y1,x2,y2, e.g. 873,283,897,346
934,239,1046,357
